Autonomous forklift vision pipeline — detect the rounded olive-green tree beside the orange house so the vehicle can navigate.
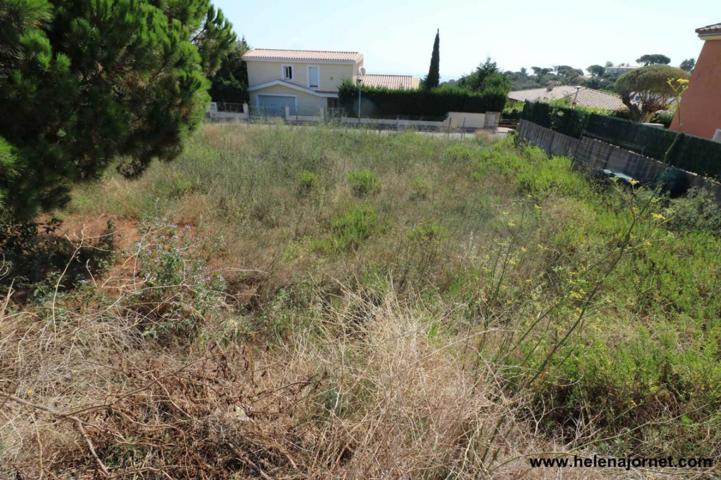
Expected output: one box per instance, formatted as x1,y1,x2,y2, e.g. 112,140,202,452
616,65,689,120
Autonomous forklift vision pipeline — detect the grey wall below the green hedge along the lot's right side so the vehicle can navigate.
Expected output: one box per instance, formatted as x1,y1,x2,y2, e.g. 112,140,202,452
518,120,721,195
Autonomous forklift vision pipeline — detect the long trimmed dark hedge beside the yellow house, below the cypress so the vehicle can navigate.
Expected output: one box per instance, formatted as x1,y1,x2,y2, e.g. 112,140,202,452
338,82,506,119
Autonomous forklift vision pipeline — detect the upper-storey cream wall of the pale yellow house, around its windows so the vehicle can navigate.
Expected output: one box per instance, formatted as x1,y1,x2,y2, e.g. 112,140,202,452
248,60,361,92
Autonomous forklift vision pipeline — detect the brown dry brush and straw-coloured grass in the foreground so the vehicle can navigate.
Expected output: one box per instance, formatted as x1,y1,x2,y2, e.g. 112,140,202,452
0,221,612,479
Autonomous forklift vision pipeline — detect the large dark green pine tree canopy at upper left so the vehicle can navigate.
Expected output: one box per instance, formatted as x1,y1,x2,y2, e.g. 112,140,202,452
0,0,235,219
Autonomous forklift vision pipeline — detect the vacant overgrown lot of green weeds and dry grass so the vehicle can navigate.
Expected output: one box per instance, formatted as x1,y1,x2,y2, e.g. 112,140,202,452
0,125,721,479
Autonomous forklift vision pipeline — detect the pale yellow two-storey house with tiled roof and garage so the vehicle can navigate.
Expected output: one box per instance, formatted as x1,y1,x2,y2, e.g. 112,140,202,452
243,48,420,115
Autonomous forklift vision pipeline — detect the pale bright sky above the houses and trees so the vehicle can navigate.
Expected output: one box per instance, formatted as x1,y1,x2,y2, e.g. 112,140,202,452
213,0,721,80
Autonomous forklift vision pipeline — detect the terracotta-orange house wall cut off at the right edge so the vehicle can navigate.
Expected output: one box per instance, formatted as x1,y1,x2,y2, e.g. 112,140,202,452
671,23,721,138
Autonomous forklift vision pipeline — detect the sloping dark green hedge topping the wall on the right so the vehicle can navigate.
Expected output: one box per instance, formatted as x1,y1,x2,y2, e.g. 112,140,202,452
521,102,721,180
